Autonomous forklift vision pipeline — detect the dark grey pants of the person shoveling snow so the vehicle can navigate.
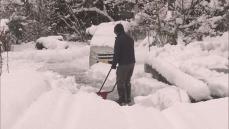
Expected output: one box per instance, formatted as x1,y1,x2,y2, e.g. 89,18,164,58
116,63,135,102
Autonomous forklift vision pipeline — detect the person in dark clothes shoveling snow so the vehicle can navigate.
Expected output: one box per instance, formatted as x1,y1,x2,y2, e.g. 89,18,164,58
111,24,135,105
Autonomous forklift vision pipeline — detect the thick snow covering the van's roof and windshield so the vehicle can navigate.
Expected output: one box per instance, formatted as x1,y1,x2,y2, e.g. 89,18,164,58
89,21,130,47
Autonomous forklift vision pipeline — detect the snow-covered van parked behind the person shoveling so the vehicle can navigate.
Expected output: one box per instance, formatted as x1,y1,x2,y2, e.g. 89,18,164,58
88,21,129,66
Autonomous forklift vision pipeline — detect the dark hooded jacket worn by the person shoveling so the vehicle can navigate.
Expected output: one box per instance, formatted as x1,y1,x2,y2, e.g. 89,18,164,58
112,26,135,66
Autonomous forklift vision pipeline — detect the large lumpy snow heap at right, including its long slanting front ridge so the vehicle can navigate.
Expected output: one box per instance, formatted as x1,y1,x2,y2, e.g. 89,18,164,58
147,33,229,100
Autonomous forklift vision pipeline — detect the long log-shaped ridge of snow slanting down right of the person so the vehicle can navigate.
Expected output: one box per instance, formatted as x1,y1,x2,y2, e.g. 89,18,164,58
147,57,210,101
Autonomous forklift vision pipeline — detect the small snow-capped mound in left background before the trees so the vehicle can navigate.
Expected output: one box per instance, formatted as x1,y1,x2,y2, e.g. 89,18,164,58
36,36,68,49
